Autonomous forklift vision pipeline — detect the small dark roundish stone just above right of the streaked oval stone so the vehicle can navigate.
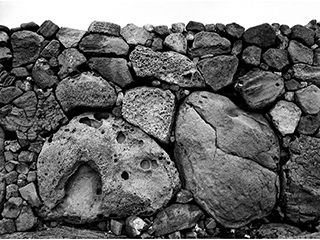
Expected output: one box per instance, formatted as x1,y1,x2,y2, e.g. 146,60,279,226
262,48,289,71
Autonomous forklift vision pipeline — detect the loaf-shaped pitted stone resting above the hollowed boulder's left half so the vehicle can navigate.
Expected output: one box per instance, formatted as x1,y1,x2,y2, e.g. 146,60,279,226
55,73,116,112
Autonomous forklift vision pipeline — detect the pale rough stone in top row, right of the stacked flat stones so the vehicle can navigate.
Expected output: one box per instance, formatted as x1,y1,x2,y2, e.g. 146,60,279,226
120,23,154,46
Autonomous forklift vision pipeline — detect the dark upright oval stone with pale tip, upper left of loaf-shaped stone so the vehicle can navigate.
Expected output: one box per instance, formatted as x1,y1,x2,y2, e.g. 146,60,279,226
32,58,58,89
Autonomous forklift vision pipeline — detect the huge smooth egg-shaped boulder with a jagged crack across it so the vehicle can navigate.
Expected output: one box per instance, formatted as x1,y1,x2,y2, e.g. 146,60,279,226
174,92,280,228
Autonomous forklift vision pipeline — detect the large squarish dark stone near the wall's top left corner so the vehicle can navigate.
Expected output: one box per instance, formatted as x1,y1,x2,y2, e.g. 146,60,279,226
11,30,44,67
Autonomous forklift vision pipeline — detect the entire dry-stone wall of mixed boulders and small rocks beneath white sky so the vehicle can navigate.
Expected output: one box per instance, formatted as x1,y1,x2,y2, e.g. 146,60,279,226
0,20,320,238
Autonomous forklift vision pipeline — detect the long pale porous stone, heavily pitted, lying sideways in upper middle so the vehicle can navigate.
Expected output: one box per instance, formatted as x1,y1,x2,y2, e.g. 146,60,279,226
129,46,205,88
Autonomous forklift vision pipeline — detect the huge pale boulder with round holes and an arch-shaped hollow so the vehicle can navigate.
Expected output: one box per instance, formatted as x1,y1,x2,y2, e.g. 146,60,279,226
37,113,180,222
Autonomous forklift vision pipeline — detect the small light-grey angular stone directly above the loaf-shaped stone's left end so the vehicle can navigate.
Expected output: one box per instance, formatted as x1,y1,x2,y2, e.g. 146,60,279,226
58,48,87,79
